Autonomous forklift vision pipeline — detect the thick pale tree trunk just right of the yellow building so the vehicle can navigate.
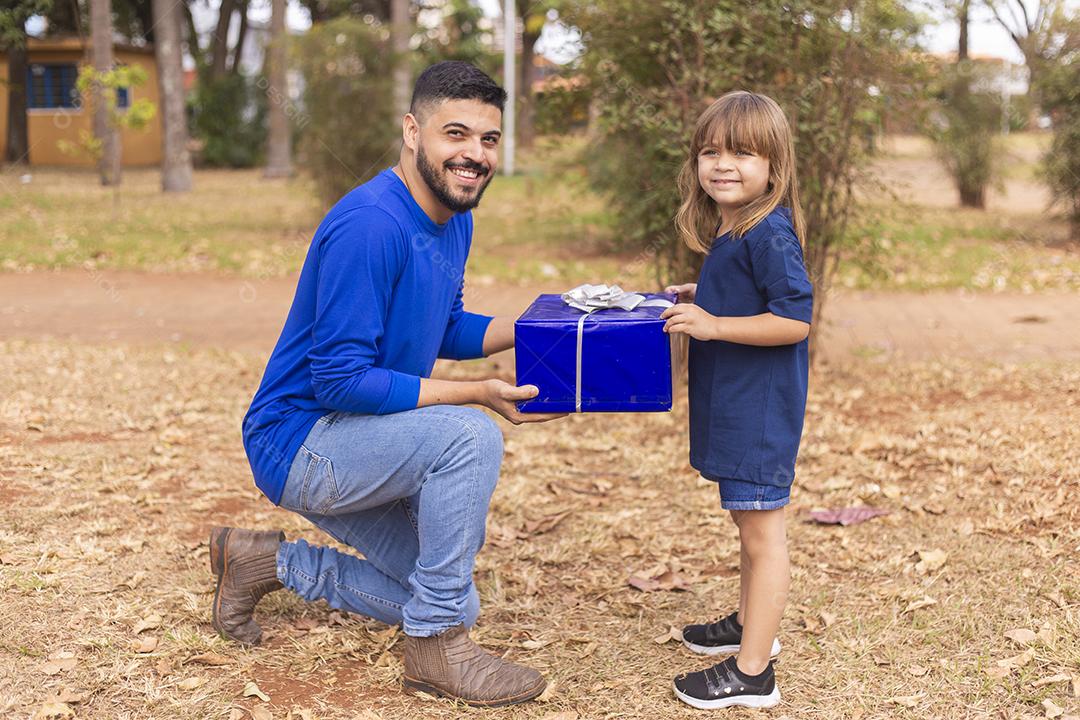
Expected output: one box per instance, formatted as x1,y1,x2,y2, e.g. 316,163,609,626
152,0,191,192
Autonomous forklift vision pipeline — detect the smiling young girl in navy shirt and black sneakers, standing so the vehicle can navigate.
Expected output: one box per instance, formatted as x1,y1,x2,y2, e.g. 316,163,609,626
663,92,813,708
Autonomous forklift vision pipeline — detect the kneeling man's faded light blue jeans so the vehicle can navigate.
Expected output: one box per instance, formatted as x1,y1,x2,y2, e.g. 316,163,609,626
278,405,502,637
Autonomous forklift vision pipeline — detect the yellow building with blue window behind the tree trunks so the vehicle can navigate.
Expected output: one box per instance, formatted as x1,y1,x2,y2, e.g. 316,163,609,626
0,38,161,167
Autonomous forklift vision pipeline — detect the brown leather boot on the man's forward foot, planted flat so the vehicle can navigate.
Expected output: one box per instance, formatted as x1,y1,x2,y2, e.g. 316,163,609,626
405,625,548,707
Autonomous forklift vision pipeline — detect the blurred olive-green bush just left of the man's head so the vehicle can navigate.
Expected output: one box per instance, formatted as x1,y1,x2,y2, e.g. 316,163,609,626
292,17,401,205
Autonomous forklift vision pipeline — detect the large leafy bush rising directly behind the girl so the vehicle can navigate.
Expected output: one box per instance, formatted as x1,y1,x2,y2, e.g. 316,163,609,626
562,0,921,321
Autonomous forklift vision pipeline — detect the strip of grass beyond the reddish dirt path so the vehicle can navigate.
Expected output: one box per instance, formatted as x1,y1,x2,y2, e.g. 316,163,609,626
0,135,1080,291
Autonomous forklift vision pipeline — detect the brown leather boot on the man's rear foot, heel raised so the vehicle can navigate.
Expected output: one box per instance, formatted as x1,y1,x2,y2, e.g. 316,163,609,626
210,528,285,646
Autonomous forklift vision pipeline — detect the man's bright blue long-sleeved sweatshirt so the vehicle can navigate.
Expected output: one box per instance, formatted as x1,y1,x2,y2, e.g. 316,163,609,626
243,169,491,504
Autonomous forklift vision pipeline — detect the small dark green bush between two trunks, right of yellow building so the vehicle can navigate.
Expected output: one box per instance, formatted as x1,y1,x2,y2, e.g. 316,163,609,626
188,68,267,167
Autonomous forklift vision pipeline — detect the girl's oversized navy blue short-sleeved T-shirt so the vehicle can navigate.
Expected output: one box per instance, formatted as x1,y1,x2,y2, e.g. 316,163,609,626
690,207,813,487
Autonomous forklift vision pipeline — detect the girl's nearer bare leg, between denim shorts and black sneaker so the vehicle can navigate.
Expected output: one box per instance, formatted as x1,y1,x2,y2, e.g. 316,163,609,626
732,507,792,675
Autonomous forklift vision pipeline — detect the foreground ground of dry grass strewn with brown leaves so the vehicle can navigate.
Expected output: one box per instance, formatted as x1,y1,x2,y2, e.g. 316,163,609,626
0,342,1080,720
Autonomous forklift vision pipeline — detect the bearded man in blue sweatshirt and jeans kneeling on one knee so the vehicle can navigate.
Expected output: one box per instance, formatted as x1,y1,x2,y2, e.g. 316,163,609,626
211,63,555,706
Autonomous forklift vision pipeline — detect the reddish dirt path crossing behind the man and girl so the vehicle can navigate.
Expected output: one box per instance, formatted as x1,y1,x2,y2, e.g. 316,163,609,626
0,271,1080,361
